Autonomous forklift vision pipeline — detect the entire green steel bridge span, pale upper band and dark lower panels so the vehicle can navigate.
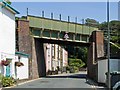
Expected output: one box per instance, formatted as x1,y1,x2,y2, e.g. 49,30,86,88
27,15,98,42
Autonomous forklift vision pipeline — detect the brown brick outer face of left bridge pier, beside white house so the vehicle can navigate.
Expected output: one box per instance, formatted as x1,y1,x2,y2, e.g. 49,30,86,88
16,20,32,79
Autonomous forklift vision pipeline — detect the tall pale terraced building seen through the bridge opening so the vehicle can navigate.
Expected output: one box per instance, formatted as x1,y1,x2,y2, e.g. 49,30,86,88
45,44,68,72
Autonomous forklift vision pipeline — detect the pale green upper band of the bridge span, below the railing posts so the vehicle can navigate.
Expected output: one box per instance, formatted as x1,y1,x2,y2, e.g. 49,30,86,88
28,16,98,35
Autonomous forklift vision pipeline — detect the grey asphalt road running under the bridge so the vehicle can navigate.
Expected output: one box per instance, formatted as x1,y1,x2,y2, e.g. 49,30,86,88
0,71,105,90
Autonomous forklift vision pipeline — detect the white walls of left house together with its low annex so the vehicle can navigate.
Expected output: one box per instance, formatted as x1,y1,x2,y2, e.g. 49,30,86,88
0,2,29,79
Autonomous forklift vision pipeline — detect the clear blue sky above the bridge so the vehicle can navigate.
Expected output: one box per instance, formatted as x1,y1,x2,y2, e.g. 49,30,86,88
12,2,118,23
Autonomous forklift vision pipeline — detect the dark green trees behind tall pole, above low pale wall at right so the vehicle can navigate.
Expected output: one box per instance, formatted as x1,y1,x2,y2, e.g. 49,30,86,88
99,20,120,57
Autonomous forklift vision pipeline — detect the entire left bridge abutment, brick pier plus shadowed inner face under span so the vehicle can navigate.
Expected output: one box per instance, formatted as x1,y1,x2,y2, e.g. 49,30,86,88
16,20,46,79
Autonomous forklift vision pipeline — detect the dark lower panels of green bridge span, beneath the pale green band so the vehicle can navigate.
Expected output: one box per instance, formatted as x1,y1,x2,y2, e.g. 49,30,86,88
30,28,89,42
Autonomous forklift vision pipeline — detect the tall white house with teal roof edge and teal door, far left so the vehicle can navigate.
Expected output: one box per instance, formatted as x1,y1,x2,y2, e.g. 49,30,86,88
0,0,19,76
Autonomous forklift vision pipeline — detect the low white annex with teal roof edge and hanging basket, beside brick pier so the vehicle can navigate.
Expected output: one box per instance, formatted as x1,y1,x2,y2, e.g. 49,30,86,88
12,52,29,80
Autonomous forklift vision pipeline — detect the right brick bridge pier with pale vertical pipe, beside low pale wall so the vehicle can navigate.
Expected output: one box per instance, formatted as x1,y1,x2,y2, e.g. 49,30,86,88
87,31,104,81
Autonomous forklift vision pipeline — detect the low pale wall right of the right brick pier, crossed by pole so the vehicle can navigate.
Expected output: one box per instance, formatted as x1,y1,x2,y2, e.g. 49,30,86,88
98,59,120,83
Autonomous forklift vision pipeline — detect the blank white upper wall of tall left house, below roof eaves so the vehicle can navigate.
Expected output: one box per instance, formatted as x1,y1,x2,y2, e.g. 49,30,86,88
0,4,15,57
